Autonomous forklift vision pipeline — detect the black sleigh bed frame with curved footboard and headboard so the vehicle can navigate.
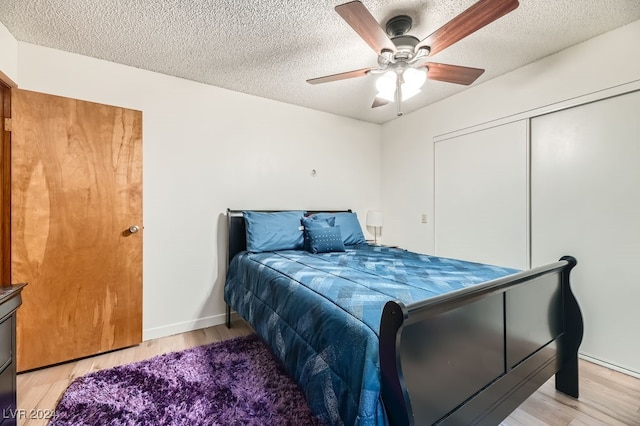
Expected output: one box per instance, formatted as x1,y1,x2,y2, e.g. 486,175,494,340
227,210,583,425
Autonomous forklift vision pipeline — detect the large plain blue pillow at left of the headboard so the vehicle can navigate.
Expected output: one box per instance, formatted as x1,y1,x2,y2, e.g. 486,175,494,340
242,210,304,253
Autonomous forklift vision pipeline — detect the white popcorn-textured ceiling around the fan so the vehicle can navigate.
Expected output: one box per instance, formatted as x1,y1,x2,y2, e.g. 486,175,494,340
0,0,640,123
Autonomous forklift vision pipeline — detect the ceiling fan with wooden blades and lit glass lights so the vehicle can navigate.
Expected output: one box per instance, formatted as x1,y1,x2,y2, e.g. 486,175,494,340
307,0,519,116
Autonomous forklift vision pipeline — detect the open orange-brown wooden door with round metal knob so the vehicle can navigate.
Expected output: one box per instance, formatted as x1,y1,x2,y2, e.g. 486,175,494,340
11,89,142,371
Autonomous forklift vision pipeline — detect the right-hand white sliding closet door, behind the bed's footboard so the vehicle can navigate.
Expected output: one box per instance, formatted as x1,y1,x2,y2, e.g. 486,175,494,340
531,92,640,374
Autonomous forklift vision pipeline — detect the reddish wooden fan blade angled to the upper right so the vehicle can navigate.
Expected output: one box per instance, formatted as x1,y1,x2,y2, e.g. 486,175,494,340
415,0,520,55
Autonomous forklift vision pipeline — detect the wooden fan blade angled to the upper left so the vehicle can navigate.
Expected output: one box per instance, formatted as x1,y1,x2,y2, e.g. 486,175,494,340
335,1,396,55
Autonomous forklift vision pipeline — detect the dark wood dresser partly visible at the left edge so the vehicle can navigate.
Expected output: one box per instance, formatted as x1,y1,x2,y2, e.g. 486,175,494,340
0,284,26,426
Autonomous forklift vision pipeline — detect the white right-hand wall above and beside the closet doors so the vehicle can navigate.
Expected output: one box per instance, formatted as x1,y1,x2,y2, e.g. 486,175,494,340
382,21,640,253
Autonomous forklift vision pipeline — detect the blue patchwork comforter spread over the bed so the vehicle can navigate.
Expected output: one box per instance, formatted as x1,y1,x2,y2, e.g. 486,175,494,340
224,244,517,425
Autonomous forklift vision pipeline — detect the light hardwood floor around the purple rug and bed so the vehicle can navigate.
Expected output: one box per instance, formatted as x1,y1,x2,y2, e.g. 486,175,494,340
18,320,640,426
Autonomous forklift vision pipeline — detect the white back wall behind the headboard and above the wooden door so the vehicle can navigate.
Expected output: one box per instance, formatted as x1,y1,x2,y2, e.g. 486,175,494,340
18,42,381,339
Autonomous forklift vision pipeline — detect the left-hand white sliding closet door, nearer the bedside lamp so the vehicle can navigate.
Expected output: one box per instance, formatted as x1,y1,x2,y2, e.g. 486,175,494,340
435,120,528,269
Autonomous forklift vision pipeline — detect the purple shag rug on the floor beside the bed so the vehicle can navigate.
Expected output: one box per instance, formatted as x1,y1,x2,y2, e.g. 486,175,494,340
49,335,321,426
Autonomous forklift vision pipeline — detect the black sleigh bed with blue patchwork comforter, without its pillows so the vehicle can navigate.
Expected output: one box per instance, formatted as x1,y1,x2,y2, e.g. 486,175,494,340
224,210,583,425
